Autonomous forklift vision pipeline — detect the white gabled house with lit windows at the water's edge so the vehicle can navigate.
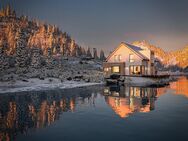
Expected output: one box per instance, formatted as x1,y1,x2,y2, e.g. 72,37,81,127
103,42,155,77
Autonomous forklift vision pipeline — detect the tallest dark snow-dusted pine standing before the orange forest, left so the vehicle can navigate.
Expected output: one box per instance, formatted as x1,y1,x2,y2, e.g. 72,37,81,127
15,29,28,73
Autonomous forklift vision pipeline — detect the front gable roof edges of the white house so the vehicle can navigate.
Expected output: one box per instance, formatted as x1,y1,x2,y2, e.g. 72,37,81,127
106,42,149,60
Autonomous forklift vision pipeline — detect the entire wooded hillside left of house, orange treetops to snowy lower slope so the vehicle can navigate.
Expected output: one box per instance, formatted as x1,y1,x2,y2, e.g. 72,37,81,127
0,6,105,82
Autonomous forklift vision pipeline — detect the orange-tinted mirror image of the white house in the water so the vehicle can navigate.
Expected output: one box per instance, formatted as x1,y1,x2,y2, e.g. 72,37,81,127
104,87,157,118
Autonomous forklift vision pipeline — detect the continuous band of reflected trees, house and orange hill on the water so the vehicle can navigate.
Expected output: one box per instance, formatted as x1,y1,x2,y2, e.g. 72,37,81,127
0,78,188,141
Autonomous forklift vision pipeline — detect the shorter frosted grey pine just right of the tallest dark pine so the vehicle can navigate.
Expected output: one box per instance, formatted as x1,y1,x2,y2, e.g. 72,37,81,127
31,47,42,69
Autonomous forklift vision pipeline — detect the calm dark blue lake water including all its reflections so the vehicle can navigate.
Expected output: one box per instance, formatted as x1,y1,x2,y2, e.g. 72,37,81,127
0,77,188,141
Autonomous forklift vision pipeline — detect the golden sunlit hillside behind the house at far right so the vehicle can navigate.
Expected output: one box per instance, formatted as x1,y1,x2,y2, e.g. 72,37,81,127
133,41,188,68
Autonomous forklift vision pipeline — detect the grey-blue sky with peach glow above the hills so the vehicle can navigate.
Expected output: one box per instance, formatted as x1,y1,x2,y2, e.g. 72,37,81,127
0,0,188,53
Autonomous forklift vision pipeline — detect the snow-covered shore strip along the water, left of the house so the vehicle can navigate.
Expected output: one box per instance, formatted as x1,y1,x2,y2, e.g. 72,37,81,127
0,78,102,93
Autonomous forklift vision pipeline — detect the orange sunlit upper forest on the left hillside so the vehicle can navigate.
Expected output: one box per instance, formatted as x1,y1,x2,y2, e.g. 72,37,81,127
0,6,89,56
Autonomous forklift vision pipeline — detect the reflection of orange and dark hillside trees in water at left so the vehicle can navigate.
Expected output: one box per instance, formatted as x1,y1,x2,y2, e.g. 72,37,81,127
0,89,100,141
